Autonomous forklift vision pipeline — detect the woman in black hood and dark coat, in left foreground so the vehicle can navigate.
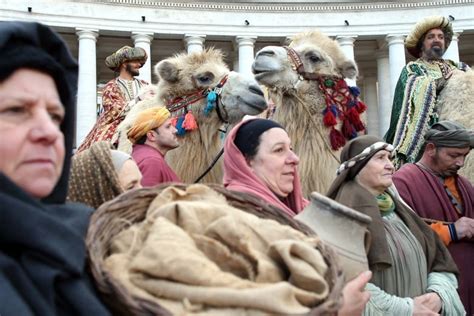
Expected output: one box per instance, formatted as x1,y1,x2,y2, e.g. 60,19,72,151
0,22,109,315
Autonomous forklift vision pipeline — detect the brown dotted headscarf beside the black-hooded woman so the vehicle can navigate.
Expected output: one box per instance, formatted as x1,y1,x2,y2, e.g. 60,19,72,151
67,142,123,208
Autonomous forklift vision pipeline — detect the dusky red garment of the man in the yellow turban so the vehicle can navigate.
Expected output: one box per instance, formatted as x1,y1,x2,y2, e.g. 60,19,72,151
132,144,181,187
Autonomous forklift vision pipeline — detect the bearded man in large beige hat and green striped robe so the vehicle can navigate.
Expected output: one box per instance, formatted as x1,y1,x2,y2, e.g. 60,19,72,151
385,16,468,169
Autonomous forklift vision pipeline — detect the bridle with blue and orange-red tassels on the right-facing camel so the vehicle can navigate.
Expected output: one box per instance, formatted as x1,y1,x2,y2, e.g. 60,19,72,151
166,75,228,136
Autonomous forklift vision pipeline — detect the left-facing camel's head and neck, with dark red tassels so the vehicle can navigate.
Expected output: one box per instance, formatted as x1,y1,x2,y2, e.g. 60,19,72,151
252,31,365,196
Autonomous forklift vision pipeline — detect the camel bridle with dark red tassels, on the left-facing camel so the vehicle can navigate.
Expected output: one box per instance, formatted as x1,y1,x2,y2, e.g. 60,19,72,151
284,46,367,150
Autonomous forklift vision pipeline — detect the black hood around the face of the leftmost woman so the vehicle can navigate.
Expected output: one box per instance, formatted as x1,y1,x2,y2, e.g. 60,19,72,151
0,22,78,204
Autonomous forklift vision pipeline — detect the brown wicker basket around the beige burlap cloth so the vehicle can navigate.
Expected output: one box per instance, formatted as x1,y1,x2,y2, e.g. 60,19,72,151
86,185,344,315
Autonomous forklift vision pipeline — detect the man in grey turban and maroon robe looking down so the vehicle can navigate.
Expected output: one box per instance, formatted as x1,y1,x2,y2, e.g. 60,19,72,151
393,121,474,315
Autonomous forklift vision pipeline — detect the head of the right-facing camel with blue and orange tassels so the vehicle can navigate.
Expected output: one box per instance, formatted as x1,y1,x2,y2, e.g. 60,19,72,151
155,48,267,125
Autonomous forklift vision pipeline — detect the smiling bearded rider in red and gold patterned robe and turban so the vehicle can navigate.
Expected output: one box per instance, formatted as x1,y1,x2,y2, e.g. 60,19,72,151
78,46,148,152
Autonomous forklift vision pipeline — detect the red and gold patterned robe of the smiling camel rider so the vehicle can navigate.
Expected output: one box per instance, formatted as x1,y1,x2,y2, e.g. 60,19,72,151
77,78,148,152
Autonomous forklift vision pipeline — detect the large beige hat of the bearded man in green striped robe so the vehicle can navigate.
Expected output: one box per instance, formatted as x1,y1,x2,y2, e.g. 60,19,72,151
405,15,453,58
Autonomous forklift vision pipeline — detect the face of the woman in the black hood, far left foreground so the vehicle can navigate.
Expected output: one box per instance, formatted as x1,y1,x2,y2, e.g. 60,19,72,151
0,69,65,198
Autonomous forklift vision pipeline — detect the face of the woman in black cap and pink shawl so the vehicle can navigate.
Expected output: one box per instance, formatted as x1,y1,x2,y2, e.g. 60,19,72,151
248,128,299,197
